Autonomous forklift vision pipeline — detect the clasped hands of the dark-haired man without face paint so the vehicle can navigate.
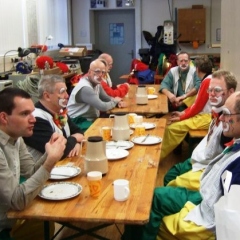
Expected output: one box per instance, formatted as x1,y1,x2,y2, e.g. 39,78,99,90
43,132,67,172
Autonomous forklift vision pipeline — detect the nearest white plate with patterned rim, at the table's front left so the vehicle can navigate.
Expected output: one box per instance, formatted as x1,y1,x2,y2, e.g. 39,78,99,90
38,182,82,200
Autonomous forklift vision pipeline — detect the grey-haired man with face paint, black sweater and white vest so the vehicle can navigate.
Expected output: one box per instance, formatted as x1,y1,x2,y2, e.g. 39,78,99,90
24,75,84,160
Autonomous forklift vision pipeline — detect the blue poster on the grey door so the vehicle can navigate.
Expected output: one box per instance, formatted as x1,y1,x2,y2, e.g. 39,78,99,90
109,23,124,45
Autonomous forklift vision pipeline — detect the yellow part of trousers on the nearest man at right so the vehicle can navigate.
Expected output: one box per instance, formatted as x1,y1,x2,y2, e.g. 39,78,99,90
157,202,216,240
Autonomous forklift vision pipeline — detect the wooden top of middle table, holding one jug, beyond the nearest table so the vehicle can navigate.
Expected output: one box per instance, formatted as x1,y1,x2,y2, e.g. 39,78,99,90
109,84,168,115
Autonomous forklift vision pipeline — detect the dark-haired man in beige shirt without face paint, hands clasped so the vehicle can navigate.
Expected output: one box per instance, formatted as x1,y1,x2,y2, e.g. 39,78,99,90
0,88,66,240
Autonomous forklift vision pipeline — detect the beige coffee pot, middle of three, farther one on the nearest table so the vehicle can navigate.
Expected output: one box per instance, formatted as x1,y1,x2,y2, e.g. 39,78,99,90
109,113,130,141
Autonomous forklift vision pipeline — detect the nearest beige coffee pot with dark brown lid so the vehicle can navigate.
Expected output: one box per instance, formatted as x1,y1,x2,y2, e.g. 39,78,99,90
84,136,108,174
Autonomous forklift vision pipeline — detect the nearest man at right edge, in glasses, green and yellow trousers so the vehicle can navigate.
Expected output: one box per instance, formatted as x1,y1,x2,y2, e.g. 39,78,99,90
122,92,240,240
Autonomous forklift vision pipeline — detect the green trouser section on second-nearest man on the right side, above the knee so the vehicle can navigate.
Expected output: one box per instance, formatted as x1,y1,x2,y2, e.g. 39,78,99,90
163,158,192,186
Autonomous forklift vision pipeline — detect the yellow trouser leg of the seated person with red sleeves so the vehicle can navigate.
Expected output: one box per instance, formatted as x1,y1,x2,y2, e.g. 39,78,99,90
161,113,211,159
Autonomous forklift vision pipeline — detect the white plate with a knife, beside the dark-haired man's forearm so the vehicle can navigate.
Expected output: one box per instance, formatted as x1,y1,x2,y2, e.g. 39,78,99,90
50,166,81,179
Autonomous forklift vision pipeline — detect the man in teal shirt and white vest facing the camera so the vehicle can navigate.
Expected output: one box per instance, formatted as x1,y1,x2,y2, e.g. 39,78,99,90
159,52,201,111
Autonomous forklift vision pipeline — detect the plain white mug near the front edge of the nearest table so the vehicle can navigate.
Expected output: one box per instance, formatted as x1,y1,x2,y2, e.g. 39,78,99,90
113,179,130,201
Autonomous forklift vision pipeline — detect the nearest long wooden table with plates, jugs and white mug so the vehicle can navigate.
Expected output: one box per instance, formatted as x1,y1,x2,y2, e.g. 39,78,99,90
8,118,166,239
